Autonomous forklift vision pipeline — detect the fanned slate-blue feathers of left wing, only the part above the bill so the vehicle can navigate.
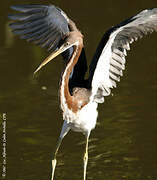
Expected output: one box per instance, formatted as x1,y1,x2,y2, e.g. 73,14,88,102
9,5,69,51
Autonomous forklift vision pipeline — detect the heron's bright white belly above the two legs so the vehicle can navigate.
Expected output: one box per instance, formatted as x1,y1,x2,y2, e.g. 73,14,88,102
69,102,98,133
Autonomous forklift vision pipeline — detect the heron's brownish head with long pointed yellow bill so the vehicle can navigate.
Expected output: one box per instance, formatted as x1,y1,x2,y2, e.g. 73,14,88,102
34,31,83,74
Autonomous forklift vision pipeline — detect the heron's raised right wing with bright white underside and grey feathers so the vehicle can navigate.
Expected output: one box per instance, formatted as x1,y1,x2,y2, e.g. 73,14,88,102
89,8,157,103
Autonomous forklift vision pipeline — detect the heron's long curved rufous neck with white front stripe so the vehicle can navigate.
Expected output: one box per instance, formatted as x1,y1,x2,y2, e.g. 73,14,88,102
60,43,83,112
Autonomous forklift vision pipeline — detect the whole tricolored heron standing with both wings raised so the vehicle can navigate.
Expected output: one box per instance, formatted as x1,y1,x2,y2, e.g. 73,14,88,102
9,5,157,180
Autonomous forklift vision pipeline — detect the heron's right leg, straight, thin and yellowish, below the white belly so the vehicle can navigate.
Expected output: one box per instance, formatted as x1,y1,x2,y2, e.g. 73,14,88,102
83,134,89,180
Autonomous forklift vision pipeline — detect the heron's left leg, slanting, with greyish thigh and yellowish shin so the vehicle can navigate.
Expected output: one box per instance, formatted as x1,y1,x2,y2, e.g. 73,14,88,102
51,121,70,180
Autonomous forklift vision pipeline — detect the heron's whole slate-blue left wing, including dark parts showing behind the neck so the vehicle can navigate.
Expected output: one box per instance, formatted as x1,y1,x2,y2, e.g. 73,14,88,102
8,5,87,89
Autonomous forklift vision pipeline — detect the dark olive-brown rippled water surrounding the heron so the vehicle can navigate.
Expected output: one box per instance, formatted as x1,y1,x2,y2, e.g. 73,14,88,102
0,0,157,180
